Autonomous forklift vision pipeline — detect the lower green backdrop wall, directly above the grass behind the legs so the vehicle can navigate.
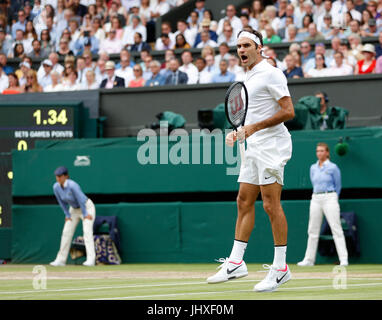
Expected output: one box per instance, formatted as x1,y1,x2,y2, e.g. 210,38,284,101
12,199,382,263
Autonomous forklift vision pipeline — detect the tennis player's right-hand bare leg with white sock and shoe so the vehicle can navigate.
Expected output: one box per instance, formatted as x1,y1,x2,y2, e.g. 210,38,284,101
254,182,291,291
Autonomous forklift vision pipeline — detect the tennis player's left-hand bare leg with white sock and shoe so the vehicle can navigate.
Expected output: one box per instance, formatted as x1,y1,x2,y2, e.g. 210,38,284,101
207,183,260,283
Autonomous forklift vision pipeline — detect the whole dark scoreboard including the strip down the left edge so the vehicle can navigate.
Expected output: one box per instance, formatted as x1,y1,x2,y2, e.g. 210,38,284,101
0,102,83,228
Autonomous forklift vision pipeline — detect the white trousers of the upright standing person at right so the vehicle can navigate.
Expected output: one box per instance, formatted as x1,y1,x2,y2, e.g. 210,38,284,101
304,192,348,263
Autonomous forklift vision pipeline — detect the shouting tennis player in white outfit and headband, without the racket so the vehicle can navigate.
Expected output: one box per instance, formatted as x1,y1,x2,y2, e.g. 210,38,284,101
207,30,294,291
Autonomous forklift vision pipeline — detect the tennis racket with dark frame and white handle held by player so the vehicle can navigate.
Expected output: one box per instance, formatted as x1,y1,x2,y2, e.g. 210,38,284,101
225,81,248,163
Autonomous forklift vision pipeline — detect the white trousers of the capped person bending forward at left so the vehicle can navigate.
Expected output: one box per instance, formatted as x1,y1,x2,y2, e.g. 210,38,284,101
56,199,96,263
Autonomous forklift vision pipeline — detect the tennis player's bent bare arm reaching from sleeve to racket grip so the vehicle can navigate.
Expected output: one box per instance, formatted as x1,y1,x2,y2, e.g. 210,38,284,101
238,96,294,139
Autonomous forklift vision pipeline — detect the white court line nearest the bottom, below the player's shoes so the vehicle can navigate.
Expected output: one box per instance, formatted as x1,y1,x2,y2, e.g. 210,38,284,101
87,282,382,300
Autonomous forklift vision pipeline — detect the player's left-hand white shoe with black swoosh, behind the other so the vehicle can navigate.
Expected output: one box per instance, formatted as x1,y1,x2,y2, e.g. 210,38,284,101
207,258,248,283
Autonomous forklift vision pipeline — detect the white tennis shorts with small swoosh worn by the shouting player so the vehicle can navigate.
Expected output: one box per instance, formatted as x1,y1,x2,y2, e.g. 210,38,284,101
237,136,292,185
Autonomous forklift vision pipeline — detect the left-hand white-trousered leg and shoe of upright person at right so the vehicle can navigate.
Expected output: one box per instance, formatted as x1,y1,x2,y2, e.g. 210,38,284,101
297,195,323,267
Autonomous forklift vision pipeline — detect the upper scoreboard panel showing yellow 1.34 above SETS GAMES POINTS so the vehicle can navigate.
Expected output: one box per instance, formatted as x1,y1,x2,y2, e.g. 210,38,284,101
0,106,78,152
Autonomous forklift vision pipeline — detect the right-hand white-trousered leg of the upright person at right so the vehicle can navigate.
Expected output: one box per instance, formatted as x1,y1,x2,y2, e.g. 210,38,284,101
323,192,348,266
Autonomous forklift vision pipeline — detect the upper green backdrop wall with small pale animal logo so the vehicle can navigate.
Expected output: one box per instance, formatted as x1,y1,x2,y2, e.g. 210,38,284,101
12,127,382,196
